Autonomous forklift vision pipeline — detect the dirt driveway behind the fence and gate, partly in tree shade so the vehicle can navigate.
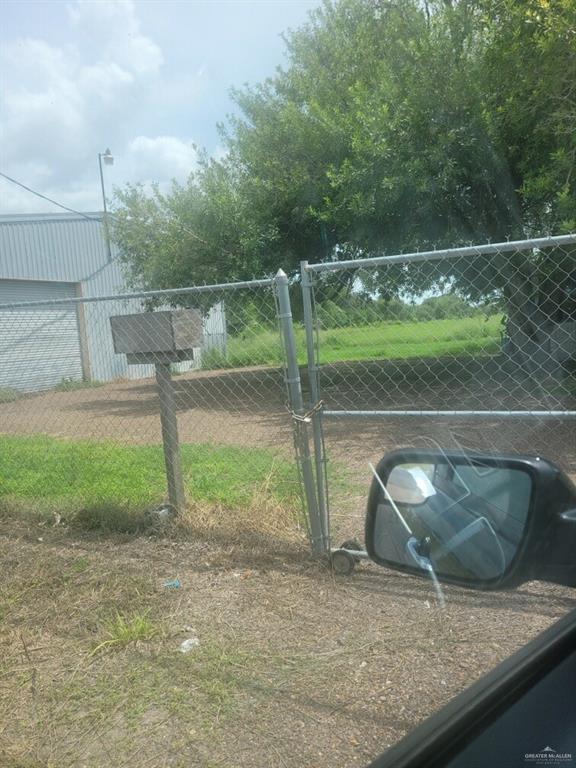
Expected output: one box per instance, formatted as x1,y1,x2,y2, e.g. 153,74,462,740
0,360,576,464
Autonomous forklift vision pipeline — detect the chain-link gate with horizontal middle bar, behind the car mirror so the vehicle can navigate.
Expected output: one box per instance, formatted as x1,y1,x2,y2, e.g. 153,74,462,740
302,235,576,544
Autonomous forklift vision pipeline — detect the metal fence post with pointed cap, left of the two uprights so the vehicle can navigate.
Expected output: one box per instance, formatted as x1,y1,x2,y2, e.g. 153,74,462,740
276,269,325,555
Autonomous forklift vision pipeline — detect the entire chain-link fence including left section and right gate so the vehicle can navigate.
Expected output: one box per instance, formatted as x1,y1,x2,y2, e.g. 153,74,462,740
0,235,576,552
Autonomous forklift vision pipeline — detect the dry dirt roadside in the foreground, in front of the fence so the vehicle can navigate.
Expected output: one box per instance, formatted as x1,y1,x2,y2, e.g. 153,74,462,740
0,519,576,768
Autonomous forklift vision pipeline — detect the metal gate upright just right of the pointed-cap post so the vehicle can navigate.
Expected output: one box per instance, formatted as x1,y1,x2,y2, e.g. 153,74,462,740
300,261,330,550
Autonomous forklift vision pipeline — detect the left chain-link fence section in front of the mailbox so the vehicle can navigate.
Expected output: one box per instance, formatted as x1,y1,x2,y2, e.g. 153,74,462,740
0,280,310,537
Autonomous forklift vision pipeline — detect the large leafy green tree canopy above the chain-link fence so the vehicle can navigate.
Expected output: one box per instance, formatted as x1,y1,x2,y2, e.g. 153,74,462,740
113,0,576,298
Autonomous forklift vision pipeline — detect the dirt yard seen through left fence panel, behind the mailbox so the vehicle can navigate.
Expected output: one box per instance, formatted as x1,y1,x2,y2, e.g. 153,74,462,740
0,368,291,447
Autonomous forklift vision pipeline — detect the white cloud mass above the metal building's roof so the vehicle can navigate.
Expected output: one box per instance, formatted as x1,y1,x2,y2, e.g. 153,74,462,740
0,0,196,213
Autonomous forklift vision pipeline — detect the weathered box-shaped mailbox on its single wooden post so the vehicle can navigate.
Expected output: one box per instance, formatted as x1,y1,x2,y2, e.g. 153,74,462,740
110,309,203,512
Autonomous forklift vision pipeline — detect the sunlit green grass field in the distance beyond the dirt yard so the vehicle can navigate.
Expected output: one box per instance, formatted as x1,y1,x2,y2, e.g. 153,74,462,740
203,315,502,368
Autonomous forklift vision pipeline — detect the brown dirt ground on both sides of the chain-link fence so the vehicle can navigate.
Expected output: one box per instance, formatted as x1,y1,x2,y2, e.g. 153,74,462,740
0,362,576,768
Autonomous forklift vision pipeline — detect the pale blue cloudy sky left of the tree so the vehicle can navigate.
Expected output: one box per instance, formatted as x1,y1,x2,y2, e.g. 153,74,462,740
0,0,321,214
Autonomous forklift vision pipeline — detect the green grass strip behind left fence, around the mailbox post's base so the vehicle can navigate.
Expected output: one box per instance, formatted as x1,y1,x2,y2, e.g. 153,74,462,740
0,435,296,531
